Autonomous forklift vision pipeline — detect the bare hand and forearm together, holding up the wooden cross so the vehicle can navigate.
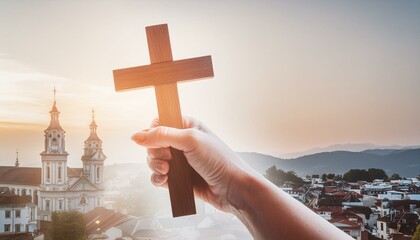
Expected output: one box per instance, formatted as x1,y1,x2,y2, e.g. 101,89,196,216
132,117,352,239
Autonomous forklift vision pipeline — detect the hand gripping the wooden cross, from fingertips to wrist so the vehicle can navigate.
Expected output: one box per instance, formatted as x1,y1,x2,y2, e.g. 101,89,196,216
132,117,253,211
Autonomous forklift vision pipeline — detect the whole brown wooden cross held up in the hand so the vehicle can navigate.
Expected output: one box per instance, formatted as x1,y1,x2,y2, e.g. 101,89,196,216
113,24,213,217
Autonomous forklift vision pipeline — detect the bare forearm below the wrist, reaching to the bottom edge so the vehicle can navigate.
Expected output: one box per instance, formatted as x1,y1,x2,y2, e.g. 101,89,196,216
229,173,351,239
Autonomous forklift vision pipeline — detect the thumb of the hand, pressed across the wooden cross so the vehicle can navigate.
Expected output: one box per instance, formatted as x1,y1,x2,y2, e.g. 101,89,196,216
131,126,199,152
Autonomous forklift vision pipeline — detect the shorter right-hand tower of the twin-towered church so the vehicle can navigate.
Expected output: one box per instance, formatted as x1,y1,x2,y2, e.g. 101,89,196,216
82,110,106,189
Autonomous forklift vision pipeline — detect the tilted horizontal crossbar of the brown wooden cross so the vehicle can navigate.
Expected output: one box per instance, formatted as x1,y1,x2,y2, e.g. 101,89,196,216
113,56,213,91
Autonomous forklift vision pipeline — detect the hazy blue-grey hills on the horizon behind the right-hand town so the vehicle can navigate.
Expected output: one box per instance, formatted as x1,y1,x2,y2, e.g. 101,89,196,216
239,148,420,177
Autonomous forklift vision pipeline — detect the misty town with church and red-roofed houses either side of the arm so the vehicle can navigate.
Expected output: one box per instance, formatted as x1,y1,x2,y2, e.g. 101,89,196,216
0,97,420,240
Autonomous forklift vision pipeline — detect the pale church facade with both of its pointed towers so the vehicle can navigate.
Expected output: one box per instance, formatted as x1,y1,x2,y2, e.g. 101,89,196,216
38,101,106,221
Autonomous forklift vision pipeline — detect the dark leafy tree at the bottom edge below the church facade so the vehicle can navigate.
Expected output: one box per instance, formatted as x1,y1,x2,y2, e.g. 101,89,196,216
51,210,86,240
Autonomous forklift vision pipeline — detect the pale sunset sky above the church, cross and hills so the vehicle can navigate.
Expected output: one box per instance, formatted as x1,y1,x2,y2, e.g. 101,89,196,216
0,0,420,167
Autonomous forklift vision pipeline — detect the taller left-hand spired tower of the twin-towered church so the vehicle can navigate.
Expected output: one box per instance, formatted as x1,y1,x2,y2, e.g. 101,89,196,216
41,89,69,191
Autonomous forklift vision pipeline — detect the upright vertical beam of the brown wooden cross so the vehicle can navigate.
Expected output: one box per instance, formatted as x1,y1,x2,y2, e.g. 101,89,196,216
146,24,196,217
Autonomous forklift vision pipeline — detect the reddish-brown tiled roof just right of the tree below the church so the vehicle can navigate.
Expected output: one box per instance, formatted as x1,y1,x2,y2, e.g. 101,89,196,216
83,207,129,235
